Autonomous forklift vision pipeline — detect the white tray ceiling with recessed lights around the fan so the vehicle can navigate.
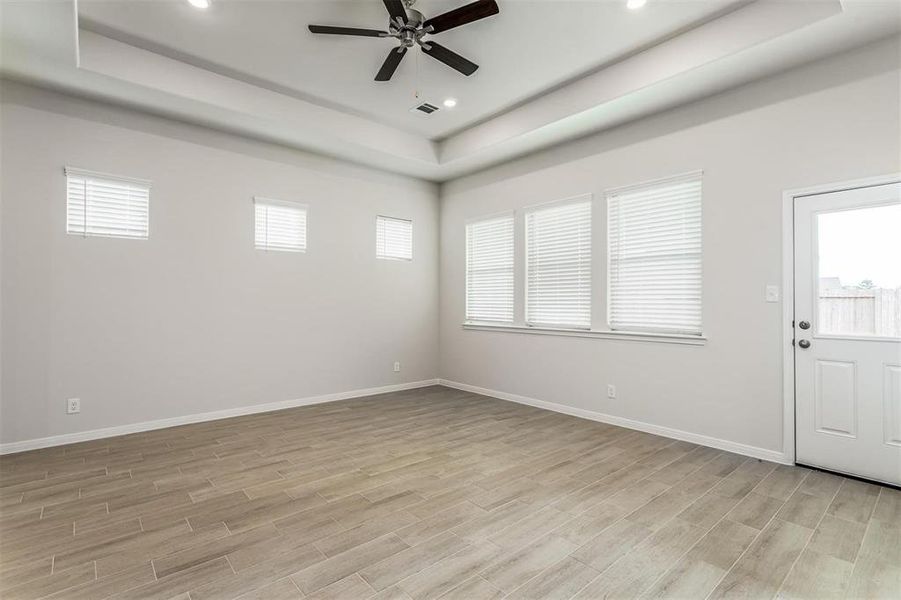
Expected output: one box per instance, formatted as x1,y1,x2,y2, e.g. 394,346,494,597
0,0,901,180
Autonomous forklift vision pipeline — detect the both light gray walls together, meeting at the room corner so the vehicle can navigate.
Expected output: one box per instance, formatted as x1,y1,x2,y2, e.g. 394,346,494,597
0,36,901,451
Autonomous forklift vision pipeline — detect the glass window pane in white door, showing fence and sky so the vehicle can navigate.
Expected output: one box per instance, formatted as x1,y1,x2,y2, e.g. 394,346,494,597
817,204,901,337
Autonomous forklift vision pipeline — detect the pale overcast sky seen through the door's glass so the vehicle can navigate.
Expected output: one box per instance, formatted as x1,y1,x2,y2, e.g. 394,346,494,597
819,204,901,288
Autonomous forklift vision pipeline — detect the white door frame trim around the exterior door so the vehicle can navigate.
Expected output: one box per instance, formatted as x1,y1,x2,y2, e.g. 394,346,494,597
782,173,901,464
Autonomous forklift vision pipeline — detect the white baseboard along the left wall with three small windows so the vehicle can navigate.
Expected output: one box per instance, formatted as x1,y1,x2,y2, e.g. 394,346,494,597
0,379,438,455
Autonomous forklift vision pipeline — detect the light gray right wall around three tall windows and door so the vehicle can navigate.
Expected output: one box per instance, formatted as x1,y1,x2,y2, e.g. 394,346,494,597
441,40,901,451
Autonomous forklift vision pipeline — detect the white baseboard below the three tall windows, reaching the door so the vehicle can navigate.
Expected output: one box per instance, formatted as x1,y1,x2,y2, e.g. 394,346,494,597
438,379,793,465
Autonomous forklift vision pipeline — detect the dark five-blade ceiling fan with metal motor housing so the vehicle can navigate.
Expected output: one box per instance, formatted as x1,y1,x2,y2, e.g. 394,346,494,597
309,0,500,81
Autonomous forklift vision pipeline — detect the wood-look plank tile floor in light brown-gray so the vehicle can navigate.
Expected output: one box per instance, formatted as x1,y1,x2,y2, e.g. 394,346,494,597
0,387,901,600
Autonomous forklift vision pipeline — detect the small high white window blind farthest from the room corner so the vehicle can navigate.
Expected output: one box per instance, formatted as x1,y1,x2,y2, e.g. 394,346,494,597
66,167,150,239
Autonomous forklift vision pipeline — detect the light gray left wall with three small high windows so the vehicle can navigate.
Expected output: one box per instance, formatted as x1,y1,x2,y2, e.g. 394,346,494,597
0,82,438,443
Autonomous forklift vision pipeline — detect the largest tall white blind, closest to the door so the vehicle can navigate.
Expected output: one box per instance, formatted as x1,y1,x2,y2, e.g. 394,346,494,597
607,173,701,335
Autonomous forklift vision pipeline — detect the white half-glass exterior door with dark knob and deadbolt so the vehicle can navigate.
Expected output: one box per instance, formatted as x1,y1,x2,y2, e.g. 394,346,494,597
794,184,901,485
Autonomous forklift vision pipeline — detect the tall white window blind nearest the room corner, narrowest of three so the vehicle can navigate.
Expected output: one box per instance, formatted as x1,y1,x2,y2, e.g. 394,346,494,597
466,215,513,323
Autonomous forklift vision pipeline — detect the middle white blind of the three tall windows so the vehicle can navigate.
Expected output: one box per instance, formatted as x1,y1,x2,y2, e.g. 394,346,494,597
526,198,591,329
